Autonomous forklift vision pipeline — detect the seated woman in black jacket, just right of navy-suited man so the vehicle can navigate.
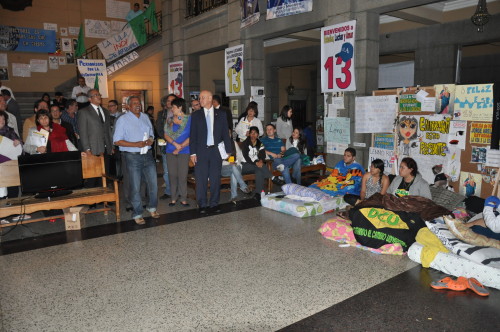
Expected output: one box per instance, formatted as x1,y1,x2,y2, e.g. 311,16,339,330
241,127,272,199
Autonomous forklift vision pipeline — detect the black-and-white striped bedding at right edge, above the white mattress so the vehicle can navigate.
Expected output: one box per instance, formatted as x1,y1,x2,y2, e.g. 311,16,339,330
425,217,500,269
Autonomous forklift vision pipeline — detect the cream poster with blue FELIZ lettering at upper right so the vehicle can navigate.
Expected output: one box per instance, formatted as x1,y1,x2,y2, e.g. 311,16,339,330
453,84,493,122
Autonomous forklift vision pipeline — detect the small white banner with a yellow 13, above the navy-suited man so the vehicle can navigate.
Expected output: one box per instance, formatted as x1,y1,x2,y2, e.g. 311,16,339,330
224,45,245,97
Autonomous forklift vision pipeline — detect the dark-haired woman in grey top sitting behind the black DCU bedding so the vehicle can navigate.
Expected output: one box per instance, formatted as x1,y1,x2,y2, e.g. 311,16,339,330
387,157,432,199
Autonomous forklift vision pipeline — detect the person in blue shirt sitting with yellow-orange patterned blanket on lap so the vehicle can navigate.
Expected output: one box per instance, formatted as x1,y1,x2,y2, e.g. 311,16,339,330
310,148,365,196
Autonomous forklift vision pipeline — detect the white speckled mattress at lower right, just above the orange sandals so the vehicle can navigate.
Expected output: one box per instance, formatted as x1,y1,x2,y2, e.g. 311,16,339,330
408,242,500,289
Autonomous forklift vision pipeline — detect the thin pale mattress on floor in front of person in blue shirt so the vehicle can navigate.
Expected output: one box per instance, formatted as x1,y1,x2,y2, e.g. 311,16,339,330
260,193,348,218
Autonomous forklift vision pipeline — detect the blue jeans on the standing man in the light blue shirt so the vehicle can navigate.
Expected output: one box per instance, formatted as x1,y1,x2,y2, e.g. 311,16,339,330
122,150,158,219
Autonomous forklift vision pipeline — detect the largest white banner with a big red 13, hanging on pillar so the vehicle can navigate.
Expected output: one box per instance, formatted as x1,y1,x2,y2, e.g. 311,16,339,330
321,21,356,93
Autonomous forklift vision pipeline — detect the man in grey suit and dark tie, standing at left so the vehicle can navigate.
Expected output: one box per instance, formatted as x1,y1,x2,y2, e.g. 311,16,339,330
78,89,113,186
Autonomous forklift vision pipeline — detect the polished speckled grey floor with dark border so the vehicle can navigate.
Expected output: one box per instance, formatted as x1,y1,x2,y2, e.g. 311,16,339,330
0,192,500,331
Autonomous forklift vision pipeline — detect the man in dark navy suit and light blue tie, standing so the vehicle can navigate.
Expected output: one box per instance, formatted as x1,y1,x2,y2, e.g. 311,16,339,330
189,90,231,214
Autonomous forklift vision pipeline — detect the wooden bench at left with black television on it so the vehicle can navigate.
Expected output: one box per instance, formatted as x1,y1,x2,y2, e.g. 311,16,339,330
0,156,120,227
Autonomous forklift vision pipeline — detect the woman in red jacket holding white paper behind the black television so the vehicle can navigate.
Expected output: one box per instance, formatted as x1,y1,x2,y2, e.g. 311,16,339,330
23,109,77,154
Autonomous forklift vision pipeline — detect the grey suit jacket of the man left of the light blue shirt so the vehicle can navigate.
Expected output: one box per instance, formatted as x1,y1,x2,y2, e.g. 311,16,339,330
78,104,113,156
